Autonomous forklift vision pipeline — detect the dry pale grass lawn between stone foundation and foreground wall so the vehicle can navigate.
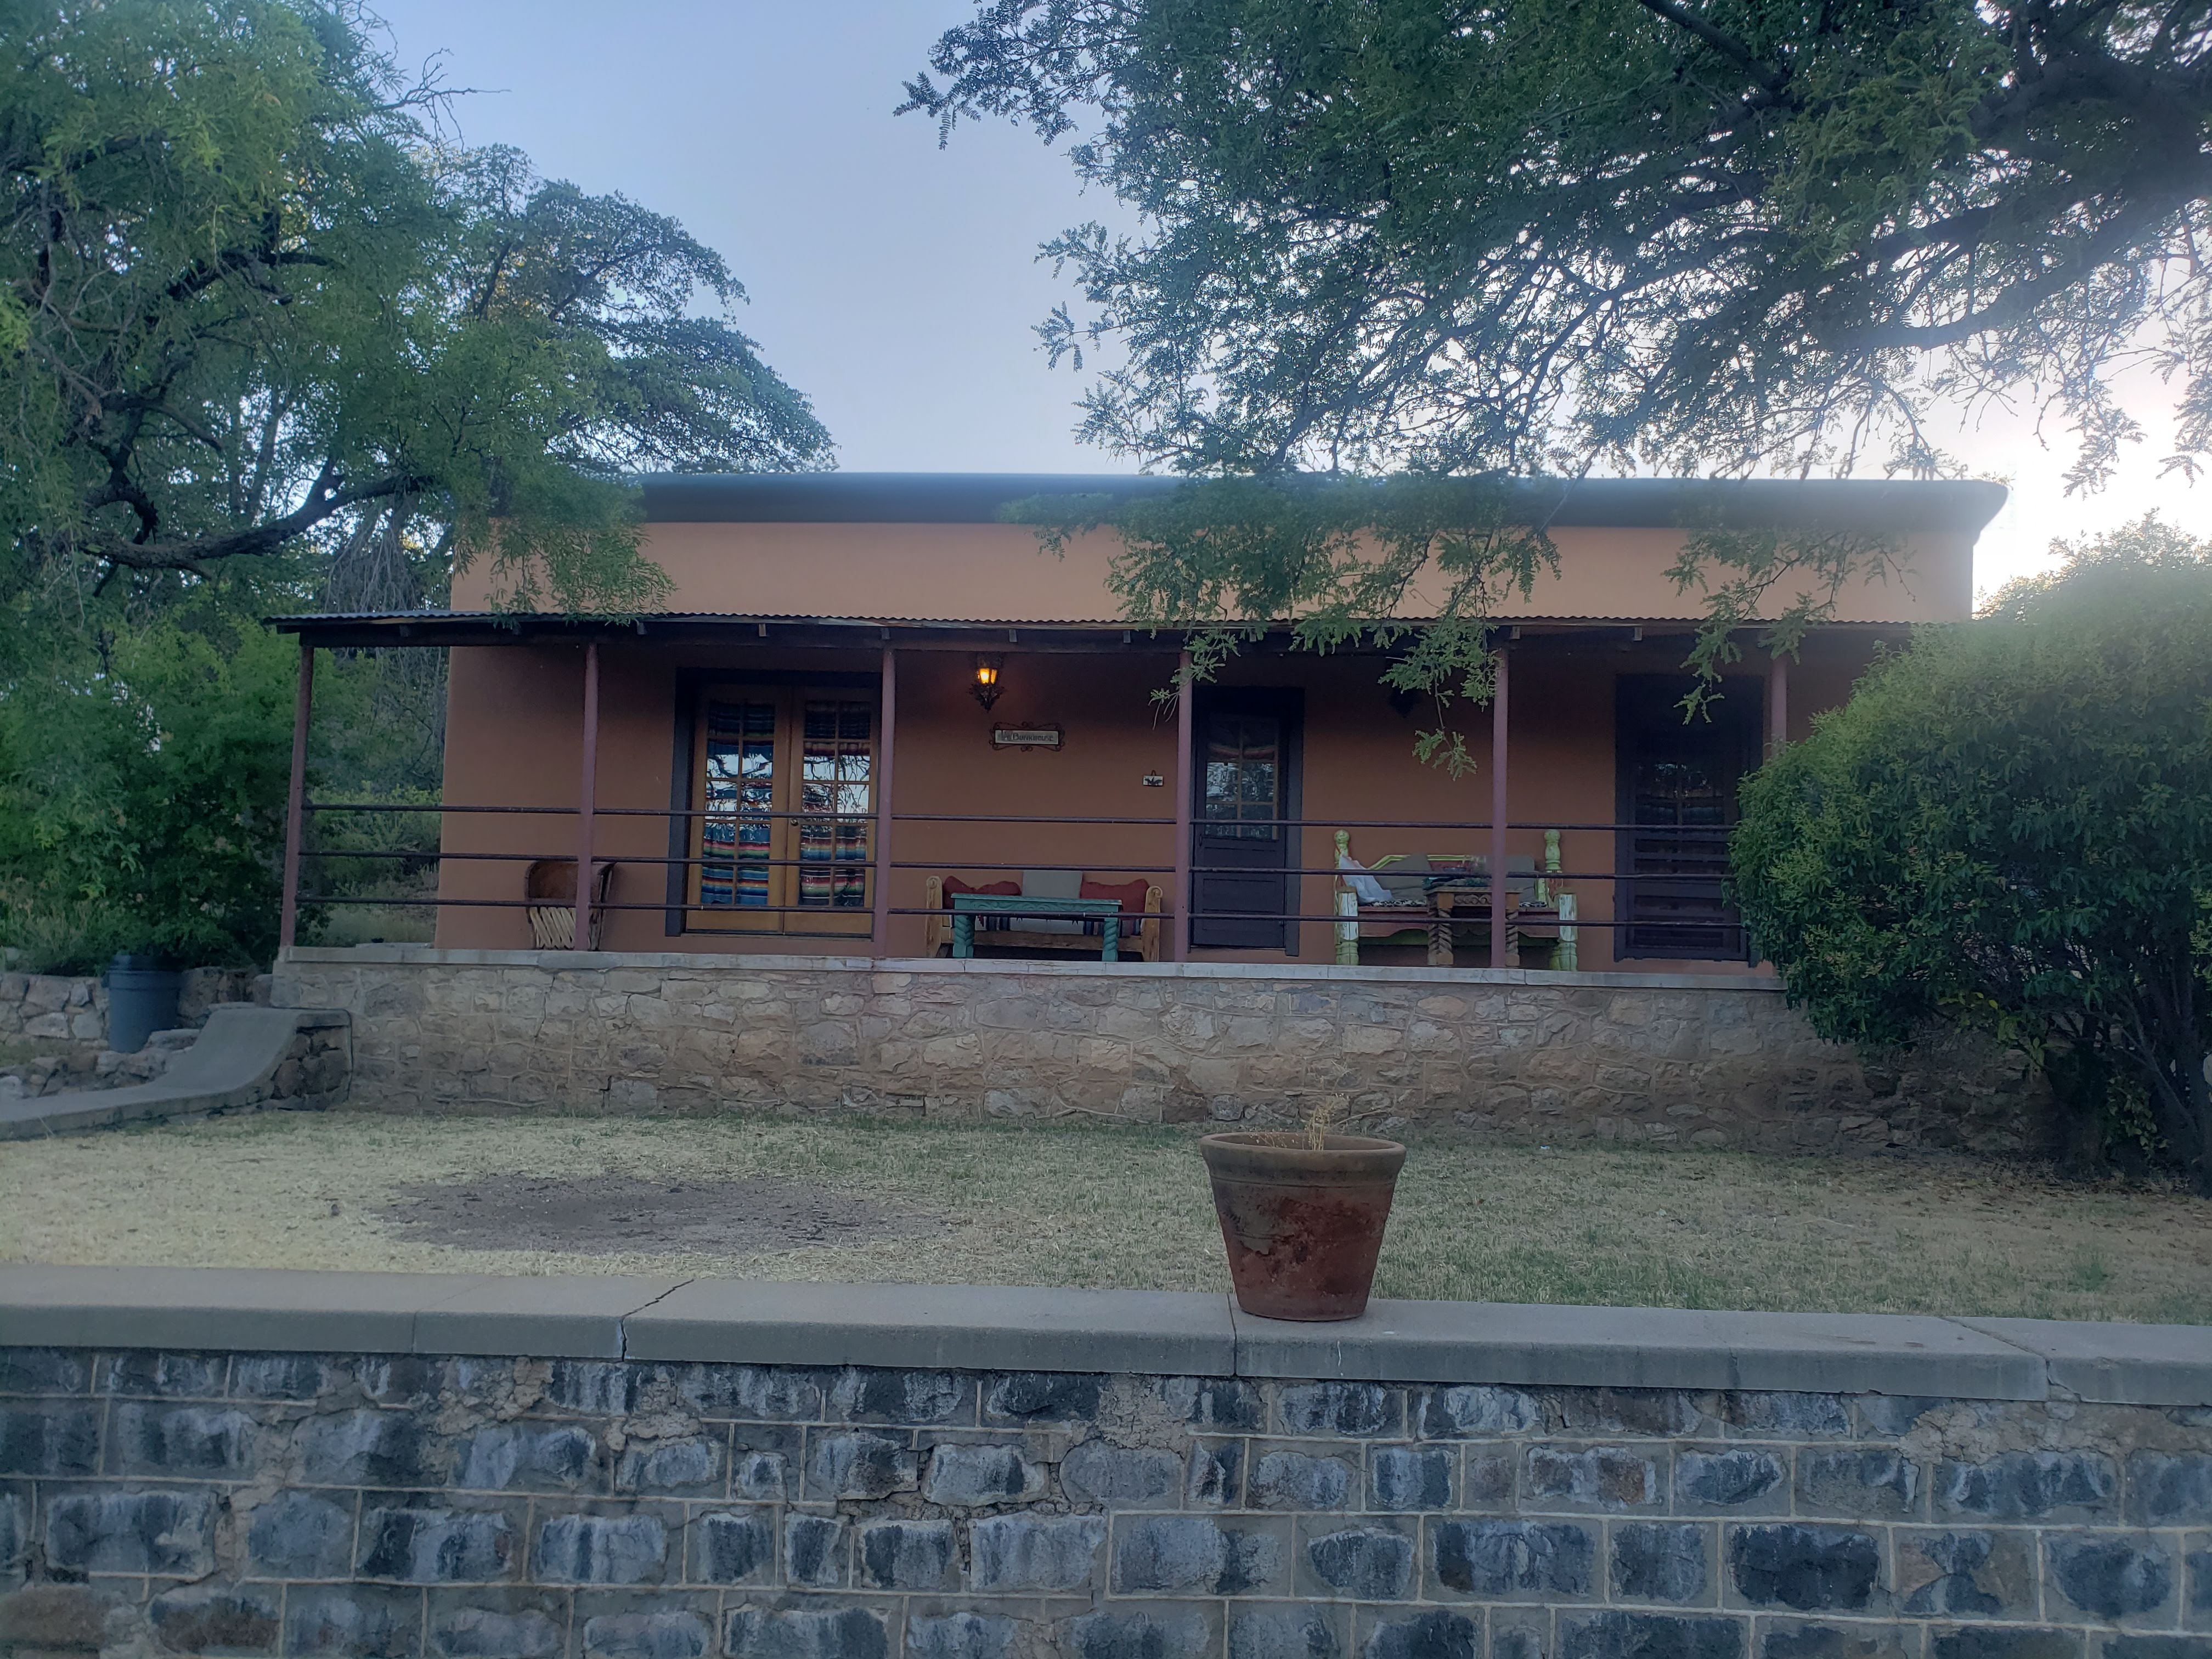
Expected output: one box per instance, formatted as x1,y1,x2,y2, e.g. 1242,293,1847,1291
0,1113,2212,1323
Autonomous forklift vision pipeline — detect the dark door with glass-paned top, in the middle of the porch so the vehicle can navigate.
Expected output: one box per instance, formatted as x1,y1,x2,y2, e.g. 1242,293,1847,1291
1190,690,1301,951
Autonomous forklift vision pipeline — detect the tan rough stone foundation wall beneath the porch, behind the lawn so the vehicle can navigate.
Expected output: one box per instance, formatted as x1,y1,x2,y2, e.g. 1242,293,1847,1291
276,947,2044,1150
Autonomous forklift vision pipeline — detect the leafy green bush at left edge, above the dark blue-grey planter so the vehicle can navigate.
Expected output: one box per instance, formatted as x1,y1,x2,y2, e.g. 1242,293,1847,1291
0,624,296,973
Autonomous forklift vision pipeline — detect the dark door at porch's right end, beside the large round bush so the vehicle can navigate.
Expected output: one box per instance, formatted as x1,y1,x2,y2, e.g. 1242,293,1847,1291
1612,675,1760,960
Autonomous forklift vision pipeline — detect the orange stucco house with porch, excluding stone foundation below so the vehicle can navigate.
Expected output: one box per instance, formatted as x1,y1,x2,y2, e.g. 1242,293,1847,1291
263,473,2004,971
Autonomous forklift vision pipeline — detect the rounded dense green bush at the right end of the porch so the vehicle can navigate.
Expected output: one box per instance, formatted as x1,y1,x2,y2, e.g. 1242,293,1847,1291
1732,520,2212,1192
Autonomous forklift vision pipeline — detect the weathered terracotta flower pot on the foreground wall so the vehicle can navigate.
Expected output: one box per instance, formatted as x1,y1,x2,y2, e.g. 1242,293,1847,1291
1199,1135,1404,1321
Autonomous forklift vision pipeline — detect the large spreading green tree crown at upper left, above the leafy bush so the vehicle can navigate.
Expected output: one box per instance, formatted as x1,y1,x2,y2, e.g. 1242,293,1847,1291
0,0,830,624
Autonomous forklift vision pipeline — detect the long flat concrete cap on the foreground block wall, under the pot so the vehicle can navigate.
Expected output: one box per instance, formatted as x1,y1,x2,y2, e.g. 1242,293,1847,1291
0,1265,2212,1407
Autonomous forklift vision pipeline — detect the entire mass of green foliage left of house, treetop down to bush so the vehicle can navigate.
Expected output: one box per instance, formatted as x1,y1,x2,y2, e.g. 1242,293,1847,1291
0,0,830,969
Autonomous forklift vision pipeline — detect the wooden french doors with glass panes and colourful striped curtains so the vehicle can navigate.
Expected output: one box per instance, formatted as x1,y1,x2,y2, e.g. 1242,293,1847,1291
690,686,876,934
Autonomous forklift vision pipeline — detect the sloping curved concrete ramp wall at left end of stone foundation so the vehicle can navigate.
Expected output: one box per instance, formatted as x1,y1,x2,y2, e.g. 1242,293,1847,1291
0,1002,352,1142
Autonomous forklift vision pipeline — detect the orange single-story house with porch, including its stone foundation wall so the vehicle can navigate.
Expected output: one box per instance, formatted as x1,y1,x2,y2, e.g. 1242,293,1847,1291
258,473,2037,1148
